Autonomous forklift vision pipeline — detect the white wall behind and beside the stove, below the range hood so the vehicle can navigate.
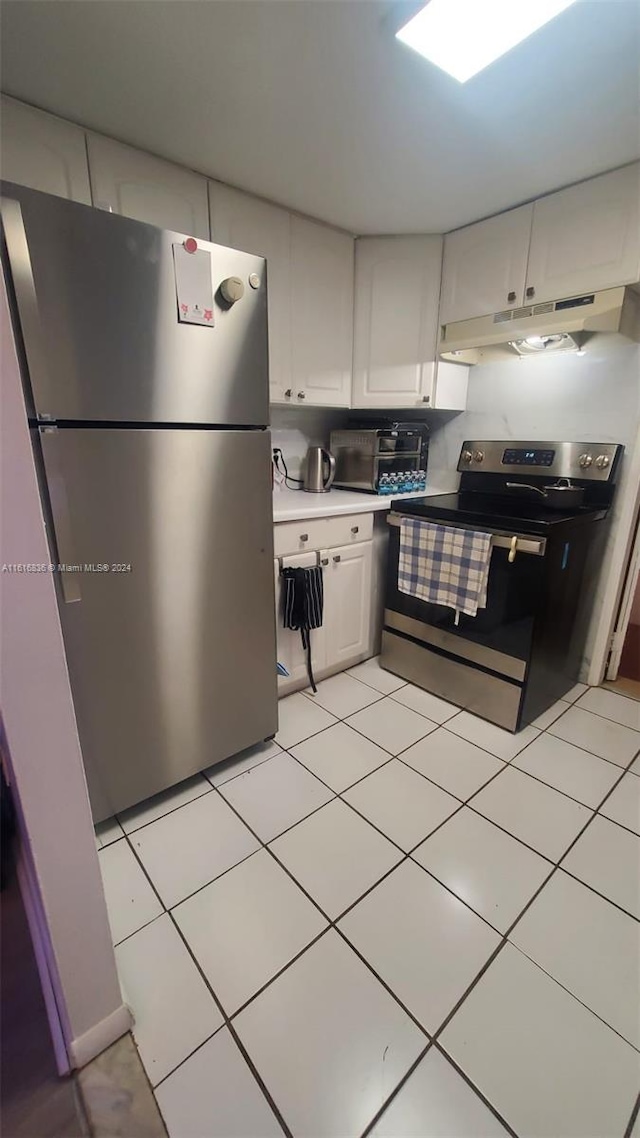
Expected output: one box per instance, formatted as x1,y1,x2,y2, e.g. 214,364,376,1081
429,336,640,676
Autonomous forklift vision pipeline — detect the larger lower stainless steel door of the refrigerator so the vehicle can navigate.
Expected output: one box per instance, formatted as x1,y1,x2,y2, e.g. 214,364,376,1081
40,428,278,820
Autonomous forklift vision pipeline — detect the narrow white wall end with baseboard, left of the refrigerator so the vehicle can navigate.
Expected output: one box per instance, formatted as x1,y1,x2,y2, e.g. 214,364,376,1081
0,273,130,1066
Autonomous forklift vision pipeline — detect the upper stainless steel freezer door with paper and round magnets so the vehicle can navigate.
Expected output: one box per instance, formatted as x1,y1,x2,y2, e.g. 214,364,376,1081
2,183,269,427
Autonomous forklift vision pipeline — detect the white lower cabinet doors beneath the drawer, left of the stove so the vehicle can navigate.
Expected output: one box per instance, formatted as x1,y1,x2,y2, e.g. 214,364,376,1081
274,530,374,695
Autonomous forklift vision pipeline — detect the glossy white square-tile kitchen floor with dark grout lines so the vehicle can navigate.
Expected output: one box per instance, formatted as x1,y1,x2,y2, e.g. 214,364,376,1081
97,660,640,1138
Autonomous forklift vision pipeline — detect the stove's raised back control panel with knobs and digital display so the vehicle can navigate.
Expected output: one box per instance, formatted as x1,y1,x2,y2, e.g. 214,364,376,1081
458,439,624,481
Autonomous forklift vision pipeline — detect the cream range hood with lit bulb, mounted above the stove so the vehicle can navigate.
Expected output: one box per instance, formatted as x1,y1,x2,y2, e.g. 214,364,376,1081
438,288,640,363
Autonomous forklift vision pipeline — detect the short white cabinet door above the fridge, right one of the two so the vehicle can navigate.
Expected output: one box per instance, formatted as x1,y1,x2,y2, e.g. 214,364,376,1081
87,134,208,240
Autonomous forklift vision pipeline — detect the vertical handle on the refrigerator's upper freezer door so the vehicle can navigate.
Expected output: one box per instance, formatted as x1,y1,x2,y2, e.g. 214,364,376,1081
0,197,50,412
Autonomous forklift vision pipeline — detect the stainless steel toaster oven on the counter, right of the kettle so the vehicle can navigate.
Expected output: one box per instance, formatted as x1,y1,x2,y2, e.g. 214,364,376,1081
330,422,428,494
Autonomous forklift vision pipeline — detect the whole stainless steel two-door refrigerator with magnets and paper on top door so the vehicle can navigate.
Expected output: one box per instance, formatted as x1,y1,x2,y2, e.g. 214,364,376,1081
2,183,278,822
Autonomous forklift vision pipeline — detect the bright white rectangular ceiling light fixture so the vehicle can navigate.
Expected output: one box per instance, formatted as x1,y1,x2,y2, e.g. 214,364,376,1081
396,0,575,83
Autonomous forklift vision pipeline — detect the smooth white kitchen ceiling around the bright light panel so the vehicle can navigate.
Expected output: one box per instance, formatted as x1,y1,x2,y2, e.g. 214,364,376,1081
1,0,640,233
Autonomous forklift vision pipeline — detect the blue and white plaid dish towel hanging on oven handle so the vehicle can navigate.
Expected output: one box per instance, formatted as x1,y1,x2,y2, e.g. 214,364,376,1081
397,518,492,624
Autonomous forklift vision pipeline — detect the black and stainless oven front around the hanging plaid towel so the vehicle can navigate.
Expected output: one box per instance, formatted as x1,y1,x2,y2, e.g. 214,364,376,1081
384,514,547,729
